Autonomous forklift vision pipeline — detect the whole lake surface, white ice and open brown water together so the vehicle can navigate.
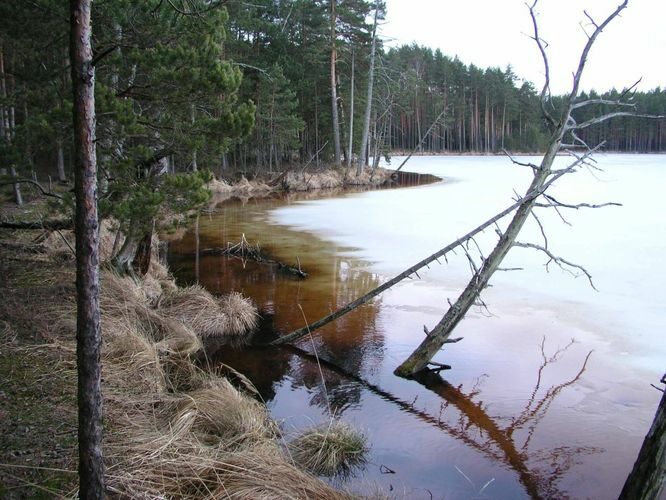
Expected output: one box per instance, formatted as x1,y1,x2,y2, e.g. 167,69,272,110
170,155,666,499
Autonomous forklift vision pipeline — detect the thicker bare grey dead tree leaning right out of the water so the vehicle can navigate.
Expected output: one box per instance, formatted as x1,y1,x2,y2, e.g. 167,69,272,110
395,0,635,377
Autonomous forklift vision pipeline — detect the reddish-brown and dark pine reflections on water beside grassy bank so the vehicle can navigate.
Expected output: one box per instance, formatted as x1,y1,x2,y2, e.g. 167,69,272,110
171,213,384,411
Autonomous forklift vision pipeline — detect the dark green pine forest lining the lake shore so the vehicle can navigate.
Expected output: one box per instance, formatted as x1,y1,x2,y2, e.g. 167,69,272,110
0,0,666,188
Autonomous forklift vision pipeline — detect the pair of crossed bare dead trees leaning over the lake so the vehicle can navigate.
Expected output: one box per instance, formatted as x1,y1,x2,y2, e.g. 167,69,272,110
271,0,663,377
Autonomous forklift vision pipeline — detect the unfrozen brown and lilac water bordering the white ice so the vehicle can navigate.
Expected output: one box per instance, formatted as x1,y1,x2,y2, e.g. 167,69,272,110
169,158,658,498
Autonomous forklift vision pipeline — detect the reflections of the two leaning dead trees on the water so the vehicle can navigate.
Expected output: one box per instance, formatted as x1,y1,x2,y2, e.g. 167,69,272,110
293,340,603,498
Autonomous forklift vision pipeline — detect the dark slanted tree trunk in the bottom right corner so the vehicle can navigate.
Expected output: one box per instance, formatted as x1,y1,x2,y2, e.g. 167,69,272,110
619,379,666,500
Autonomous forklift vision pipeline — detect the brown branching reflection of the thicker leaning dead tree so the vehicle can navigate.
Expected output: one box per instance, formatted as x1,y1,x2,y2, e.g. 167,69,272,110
417,338,592,498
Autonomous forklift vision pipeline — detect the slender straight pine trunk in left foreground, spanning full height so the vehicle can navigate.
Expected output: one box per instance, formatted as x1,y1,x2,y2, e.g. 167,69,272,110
70,0,104,499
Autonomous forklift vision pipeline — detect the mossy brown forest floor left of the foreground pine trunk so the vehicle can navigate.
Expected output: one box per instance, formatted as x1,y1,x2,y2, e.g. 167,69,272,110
0,230,77,498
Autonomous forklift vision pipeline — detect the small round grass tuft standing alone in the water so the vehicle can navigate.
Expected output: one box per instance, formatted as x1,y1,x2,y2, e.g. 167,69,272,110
289,420,368,476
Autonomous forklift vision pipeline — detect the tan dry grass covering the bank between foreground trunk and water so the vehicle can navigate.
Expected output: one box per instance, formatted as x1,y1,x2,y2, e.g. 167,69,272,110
91,269,348,499
